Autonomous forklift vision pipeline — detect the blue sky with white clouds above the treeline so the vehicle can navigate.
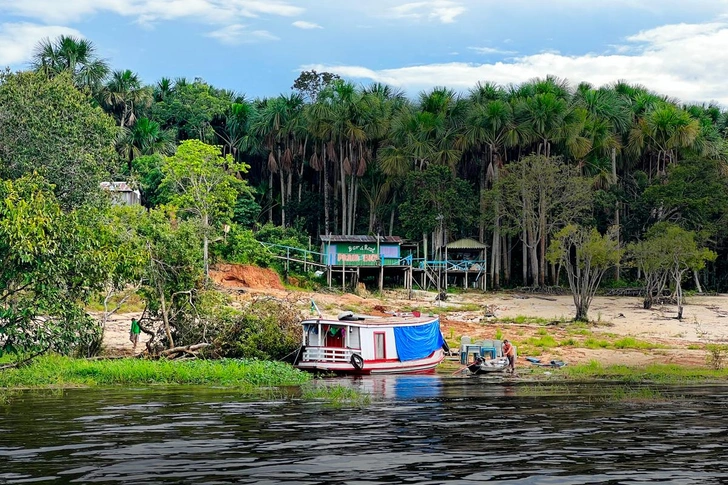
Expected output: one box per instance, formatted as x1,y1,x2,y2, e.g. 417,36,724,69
0,0,728,107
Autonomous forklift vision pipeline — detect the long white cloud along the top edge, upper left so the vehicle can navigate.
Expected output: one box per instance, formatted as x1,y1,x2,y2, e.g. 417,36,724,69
0,0,304,23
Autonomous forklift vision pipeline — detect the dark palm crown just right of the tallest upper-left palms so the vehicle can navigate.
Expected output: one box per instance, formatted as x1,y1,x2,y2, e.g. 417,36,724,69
99,69,152,127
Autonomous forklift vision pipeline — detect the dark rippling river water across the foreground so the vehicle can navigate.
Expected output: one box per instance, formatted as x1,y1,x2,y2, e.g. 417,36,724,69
0,376,728,484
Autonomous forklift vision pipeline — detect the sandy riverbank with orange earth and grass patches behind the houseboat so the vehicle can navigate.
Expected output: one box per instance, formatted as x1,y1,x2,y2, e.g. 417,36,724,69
104,266,728,367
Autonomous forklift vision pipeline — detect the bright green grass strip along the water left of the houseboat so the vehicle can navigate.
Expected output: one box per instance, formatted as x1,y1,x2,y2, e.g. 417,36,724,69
0,356,310,394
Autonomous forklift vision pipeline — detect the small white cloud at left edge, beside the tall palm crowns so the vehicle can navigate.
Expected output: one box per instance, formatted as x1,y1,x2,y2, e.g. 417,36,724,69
0,22,83,66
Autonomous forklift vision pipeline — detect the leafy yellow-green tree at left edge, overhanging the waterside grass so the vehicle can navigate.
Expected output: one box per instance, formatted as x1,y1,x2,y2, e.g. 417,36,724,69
0,175,127,354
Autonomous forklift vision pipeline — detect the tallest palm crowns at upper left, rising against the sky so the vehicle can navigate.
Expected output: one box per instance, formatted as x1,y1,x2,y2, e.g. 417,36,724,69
31,35,109,92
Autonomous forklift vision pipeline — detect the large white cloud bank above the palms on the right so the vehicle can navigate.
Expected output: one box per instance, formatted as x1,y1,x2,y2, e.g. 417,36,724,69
303,22,728,105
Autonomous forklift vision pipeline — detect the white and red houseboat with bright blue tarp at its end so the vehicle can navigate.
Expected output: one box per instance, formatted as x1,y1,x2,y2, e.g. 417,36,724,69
295,306,446,375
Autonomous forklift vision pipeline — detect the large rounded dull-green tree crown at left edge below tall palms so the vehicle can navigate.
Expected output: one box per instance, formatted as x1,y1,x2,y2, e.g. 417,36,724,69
0,72,117,208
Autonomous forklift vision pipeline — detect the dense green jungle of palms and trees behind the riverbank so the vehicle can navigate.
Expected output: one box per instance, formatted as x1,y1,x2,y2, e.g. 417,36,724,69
0,33,728,348
